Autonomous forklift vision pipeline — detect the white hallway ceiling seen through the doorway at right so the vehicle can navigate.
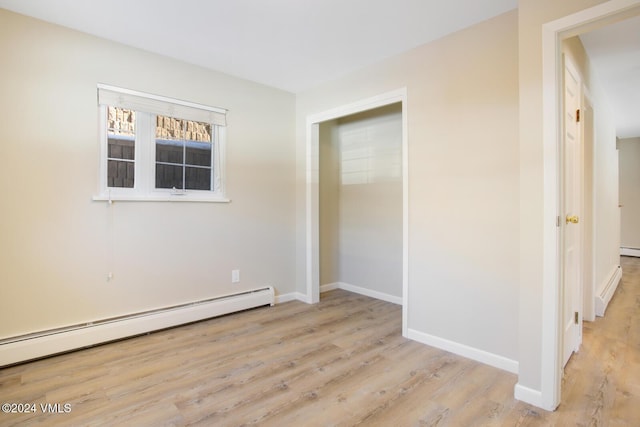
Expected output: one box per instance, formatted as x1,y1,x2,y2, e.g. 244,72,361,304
580,16,640,138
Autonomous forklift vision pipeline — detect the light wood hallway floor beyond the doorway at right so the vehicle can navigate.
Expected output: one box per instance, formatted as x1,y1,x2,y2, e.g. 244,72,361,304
549,257,640,426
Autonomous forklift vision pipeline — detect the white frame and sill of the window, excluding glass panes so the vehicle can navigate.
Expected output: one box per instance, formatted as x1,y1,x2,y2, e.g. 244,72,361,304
93,84,230,203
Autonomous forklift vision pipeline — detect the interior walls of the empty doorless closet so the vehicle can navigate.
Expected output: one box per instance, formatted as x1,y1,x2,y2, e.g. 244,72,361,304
319,104,402,298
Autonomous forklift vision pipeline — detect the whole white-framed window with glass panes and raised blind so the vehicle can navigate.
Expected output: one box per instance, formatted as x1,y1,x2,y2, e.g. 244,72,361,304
94,85,228,201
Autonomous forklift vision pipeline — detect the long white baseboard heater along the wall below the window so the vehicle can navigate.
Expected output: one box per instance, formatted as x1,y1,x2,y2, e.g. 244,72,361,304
0,286,275,367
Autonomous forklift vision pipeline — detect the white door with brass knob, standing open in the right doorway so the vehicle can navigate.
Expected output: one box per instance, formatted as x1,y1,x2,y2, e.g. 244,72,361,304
560,58,582,366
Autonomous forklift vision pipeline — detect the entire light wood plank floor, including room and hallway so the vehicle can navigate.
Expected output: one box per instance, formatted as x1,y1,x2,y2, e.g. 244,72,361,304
0,258,640,427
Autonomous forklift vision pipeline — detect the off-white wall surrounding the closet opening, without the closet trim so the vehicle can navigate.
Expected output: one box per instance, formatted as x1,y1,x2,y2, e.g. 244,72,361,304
296,11,519,361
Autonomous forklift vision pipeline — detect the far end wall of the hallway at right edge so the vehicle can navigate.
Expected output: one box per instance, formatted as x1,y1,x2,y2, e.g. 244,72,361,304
618,137,640,249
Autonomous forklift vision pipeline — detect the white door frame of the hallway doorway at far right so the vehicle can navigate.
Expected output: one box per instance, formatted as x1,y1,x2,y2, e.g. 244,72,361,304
538,0,640,410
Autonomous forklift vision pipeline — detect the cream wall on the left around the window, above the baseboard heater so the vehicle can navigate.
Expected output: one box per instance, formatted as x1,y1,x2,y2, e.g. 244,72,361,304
0,10,295,338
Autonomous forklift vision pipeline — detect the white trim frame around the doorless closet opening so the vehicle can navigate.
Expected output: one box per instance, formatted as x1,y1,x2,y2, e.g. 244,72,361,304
305,87,409,337
